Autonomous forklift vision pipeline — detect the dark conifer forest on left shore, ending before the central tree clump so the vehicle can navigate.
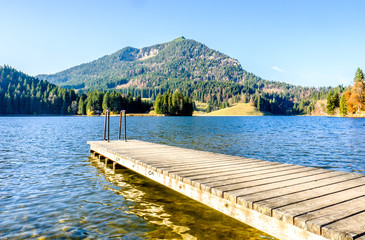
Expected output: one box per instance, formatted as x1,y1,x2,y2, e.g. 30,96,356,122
0,66,152,115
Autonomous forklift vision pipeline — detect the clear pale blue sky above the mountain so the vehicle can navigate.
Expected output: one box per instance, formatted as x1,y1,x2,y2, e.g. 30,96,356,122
0,0,365,87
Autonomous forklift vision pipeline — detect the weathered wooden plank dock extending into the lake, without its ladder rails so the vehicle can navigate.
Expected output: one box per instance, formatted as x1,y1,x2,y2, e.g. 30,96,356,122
88,140,365,240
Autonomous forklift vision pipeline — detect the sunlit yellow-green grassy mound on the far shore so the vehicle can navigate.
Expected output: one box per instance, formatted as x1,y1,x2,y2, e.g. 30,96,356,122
199,103,272,116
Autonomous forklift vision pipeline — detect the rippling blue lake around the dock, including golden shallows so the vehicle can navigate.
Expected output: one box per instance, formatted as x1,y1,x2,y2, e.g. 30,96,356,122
0,116,365,239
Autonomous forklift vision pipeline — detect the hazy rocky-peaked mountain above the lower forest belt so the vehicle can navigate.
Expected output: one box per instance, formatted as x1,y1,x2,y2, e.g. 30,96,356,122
38,37,253,89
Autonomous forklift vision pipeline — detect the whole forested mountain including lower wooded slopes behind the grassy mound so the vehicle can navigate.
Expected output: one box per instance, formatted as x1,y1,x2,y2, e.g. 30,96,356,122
38,37,329,114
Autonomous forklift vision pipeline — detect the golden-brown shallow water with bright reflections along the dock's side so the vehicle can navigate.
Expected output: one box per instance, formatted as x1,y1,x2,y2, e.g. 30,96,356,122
92,159,274,240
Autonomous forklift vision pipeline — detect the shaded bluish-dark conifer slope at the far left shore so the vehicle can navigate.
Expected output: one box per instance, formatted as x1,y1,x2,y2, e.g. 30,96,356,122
0,66,78,115
